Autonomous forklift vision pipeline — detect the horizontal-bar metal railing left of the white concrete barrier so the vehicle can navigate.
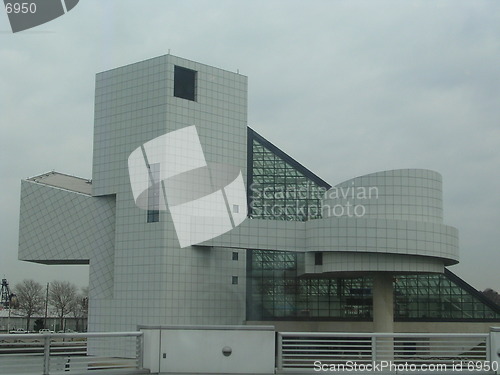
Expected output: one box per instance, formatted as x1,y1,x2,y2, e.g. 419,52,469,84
0,332,148,375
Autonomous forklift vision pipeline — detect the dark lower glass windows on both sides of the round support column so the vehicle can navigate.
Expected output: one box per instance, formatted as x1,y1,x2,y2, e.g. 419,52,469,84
247,250,500,321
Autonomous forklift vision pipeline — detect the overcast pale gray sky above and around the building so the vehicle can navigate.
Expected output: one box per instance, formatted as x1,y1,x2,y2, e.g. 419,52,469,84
0,0,500,290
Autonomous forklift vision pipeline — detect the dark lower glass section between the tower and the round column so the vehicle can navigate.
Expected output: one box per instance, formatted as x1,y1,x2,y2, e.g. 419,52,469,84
247,250,372,320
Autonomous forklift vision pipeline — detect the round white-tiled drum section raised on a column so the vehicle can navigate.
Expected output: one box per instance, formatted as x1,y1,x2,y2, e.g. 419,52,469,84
303,169,459,273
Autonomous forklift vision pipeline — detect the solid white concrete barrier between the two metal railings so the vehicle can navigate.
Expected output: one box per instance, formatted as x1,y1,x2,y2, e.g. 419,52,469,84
139,326,275,374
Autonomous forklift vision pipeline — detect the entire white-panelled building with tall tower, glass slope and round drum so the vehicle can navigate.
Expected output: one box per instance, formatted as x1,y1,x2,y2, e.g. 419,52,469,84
19,55,500,332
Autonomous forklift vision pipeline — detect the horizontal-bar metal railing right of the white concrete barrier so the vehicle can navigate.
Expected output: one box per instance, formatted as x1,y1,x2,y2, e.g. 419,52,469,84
276,332,492,373
